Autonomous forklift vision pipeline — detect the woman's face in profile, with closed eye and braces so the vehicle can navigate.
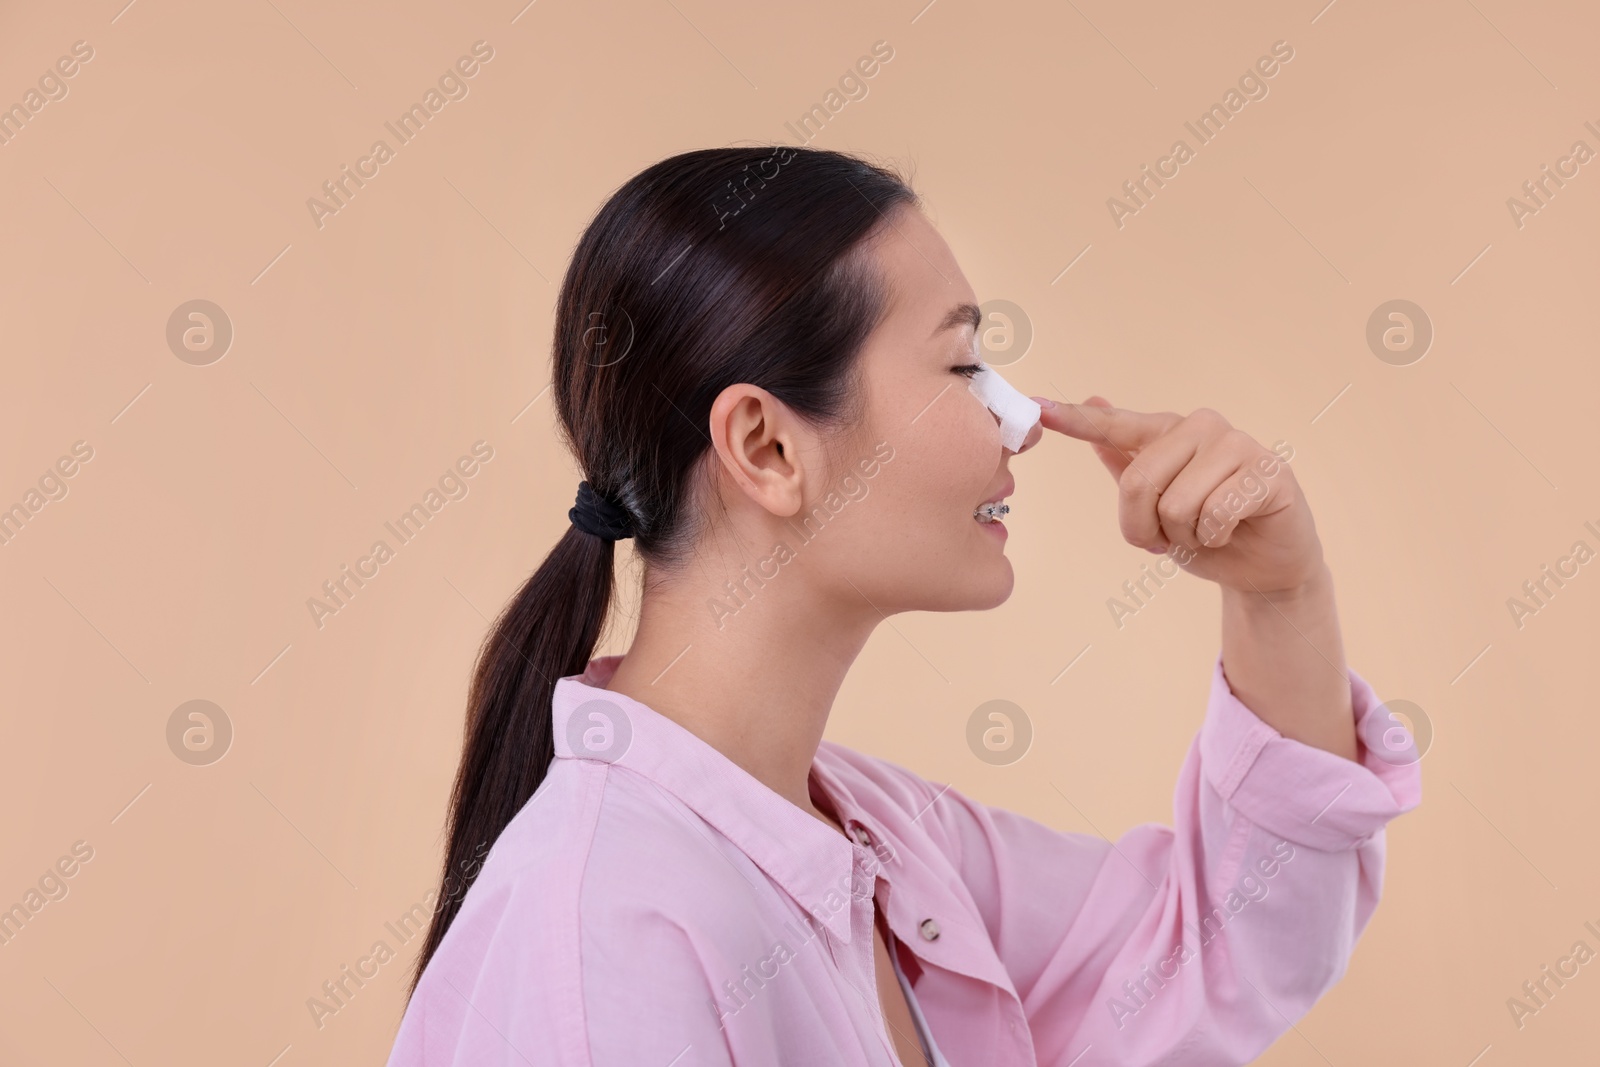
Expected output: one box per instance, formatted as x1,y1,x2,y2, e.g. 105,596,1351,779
806,208,1043,614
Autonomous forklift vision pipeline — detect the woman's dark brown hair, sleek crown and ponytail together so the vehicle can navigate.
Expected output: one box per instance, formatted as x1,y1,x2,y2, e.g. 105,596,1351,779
411,147,917,990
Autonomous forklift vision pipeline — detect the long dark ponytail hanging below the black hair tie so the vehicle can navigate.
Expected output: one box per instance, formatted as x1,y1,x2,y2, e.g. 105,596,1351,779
410,526,616,992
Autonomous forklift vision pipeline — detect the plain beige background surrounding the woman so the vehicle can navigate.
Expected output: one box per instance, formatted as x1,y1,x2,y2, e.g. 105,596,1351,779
0,0,1600,1067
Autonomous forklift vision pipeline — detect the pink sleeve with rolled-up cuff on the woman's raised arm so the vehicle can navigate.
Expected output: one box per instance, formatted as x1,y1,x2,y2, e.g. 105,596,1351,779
930,654,1421,1067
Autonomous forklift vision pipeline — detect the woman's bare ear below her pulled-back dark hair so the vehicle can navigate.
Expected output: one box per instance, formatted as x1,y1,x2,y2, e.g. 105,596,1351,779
710,382,808,517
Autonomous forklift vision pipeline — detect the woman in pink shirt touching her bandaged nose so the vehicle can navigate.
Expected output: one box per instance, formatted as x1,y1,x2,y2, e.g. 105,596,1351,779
389,149,1421,1067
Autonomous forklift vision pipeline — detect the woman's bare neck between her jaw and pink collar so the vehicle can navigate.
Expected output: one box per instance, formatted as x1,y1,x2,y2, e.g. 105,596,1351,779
606,552,882,825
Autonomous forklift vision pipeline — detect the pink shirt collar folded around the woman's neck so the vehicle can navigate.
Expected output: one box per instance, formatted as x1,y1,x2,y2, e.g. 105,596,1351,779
550,656,872,944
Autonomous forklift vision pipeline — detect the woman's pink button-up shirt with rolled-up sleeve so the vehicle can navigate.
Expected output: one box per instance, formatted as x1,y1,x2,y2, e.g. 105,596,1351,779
389,656,1421,1067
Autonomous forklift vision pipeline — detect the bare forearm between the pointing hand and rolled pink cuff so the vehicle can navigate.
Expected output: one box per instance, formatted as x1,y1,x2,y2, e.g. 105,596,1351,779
1222,565,1357,760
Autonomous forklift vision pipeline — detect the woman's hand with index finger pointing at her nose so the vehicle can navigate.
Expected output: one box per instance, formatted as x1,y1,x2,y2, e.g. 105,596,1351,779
1034,397,1323,593
